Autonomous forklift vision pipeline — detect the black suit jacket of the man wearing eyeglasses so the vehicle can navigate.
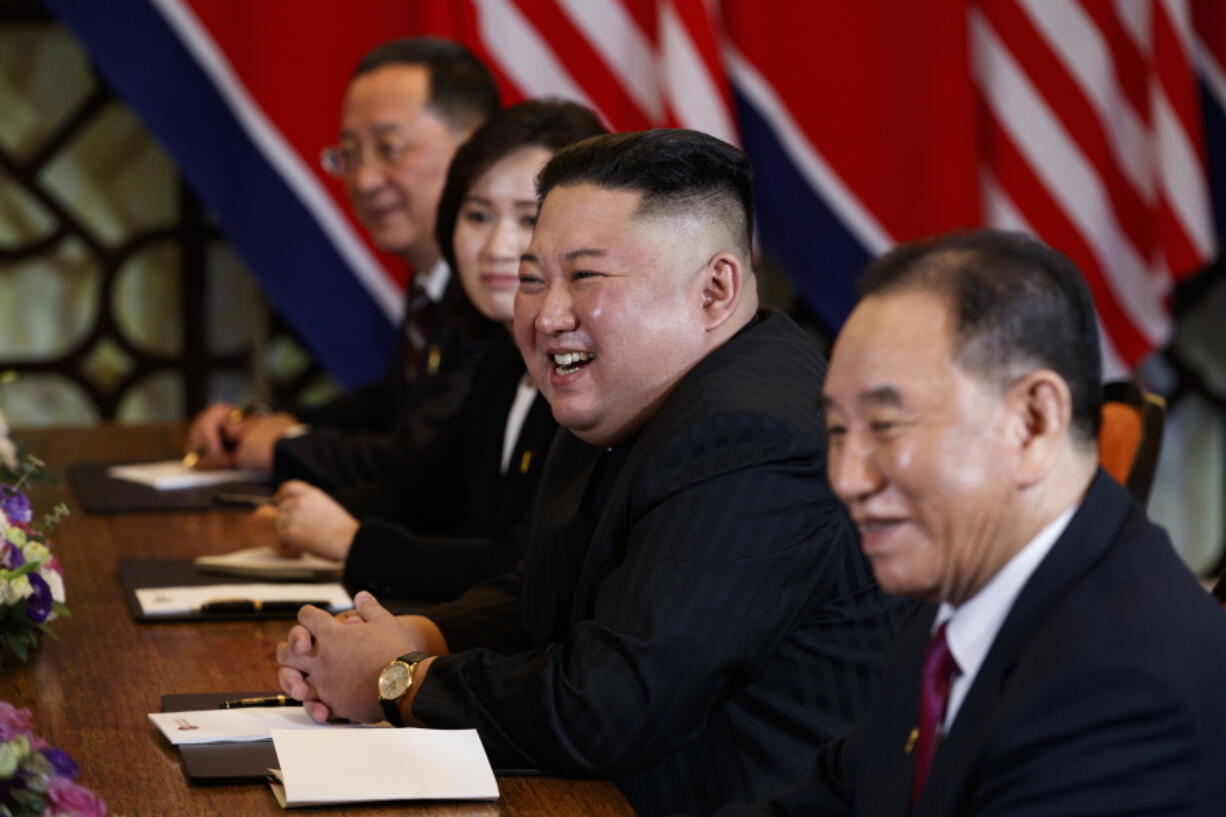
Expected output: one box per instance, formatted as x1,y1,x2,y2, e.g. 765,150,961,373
272,269,492,491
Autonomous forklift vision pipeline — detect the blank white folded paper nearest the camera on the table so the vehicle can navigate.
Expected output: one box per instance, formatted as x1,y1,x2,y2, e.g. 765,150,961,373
271,729,498,807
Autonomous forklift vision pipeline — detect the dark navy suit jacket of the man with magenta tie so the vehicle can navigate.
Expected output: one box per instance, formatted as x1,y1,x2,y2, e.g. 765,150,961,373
722,471,1226,817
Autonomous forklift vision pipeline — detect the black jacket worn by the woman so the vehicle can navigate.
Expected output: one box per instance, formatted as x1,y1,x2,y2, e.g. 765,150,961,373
335,331,558,600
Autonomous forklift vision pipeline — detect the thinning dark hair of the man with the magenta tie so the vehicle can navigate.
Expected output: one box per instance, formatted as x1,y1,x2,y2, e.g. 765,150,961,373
859,229,1102,442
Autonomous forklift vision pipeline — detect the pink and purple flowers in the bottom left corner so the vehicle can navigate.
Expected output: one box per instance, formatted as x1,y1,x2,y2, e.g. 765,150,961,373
0,700,107,817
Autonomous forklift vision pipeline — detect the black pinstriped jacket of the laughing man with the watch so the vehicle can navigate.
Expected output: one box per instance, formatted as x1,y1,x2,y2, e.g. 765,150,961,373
413,314,896,816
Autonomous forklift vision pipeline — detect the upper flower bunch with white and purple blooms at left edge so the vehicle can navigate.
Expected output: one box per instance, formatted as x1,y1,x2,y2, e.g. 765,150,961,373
0,373,69,669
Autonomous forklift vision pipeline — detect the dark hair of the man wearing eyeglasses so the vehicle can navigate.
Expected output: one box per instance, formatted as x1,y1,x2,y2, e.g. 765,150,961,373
349,37,501,130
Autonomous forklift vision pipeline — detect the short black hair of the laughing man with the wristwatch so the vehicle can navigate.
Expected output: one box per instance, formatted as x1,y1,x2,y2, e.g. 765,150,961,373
537,128,754,256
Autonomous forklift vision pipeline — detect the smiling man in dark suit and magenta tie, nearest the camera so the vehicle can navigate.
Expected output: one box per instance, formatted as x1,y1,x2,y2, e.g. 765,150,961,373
721,232,1226,817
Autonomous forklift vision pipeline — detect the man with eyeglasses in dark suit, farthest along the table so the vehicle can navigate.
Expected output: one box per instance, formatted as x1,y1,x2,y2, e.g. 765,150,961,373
186,37,499,487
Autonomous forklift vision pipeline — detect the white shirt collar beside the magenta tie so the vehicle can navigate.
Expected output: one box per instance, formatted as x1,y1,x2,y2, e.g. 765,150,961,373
933,505,1076,677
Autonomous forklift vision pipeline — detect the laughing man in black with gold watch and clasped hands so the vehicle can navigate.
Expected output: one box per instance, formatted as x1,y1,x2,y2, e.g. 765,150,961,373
278,130,912,815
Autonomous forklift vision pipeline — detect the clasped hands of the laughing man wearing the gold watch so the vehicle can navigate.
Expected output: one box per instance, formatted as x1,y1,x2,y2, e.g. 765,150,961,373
277,591,428,724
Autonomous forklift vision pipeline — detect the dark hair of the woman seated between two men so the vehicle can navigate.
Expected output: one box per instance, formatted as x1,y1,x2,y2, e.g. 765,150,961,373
434,99,606,271
